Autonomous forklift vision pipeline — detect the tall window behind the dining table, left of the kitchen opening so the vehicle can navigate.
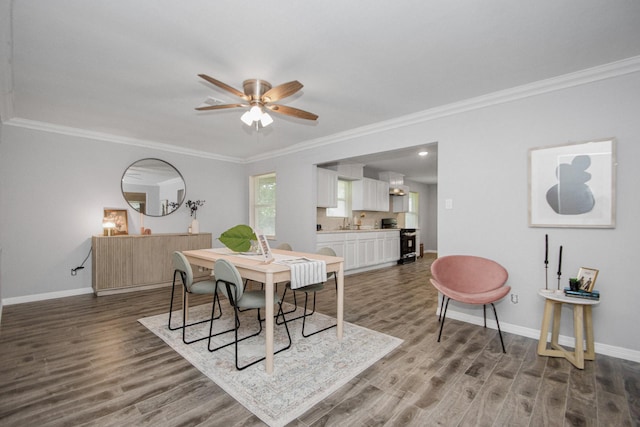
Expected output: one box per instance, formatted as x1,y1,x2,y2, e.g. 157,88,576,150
249,172,276,237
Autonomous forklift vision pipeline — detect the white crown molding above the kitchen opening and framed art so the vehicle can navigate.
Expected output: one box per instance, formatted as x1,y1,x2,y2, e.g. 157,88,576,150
246,56,640,162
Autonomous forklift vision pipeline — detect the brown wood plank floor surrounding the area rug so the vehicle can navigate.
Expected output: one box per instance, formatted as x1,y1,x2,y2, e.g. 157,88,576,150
0,258,640,427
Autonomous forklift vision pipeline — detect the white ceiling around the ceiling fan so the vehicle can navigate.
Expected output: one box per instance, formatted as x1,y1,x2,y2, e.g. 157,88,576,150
0,0,640,182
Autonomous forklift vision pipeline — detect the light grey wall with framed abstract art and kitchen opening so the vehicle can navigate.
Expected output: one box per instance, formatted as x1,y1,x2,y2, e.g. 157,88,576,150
250,72,640,357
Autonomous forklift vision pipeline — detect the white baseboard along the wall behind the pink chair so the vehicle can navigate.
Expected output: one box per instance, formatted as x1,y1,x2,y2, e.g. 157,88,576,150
436,306,640,363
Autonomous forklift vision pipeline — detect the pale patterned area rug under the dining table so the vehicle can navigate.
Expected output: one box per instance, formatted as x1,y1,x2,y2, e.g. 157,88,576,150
138,303,402,426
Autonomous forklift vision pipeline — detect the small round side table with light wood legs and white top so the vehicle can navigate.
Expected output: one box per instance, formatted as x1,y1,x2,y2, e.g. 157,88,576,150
538,290,600,369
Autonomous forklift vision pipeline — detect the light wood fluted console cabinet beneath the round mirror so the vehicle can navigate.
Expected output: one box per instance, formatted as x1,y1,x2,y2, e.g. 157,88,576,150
91,233,212,295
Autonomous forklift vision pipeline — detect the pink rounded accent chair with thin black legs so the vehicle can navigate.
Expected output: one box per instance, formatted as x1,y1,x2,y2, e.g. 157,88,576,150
431,255,511,353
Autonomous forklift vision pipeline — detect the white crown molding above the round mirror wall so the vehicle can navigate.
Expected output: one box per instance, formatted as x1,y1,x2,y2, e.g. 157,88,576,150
4,118,245,163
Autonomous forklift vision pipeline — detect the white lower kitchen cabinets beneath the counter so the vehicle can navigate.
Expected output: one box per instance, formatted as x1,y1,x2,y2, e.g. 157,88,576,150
316,230,400,271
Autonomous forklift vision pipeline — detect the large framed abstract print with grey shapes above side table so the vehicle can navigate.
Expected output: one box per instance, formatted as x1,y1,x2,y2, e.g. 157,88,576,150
528,137,616,228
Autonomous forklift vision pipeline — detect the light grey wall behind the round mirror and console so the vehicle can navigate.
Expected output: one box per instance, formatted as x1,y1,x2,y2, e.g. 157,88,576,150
0,125,248,300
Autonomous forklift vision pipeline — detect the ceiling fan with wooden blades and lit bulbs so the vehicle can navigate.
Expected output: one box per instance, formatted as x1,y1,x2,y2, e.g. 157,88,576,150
196,74,318,128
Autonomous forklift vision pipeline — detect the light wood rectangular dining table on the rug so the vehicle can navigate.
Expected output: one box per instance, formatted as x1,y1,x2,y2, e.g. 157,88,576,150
182,248,344,374
